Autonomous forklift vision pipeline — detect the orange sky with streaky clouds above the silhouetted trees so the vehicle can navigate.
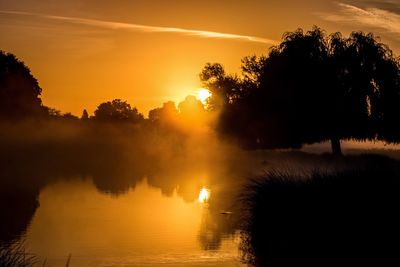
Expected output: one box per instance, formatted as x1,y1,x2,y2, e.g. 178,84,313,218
0,0,400,116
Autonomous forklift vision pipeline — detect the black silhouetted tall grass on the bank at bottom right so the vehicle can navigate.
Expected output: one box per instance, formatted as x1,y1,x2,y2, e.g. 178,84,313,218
241,156,400,266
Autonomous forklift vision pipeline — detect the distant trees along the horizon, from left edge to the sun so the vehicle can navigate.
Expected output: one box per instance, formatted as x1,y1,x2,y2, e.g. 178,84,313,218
0,50,204,123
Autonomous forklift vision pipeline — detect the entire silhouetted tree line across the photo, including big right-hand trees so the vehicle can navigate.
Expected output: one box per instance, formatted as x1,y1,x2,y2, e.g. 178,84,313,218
0,27,400,154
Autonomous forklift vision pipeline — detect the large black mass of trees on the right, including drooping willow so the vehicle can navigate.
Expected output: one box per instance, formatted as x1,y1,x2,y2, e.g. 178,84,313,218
200,27,400,154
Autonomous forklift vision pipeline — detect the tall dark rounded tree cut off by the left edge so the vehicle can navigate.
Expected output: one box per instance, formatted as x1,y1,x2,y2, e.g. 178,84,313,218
0,50,44,119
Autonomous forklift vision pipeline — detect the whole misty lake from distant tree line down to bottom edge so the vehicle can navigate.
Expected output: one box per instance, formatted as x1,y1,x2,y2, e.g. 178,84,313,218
0,121,397,266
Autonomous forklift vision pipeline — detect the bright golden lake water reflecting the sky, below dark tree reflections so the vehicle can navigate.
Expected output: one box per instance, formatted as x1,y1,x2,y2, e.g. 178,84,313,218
24,179,245,266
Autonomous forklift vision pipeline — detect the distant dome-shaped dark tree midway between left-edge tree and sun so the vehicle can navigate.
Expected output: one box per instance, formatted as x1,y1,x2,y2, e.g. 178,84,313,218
94,99,143,123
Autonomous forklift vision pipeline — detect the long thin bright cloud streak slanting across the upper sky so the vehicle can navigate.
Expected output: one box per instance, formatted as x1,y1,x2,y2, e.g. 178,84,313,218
0,10,278,45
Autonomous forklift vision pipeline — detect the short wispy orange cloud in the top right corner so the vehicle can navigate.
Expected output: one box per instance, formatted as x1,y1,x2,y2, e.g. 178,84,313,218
317,3,400,35
